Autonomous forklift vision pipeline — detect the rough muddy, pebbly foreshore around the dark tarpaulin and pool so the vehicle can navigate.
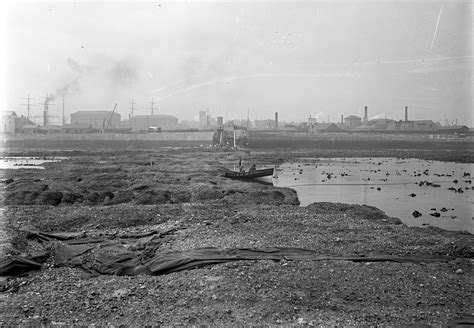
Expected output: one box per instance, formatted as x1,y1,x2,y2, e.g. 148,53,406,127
0,149,474,327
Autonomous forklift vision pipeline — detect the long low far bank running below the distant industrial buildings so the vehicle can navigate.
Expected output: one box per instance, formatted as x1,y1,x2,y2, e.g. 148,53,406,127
0,131,474,164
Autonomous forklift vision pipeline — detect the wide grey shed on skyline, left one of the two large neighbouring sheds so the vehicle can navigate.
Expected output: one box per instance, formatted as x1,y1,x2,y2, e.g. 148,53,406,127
71,110,120,129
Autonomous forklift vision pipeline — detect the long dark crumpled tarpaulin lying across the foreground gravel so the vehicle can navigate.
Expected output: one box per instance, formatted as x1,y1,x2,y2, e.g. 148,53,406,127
0,229,453,276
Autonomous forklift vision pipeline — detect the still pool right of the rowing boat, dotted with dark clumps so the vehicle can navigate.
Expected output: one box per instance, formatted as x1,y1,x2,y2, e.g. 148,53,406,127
274,158,474,233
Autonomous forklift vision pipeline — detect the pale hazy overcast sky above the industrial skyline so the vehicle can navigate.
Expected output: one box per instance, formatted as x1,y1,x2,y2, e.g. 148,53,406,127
2,0,474,126
